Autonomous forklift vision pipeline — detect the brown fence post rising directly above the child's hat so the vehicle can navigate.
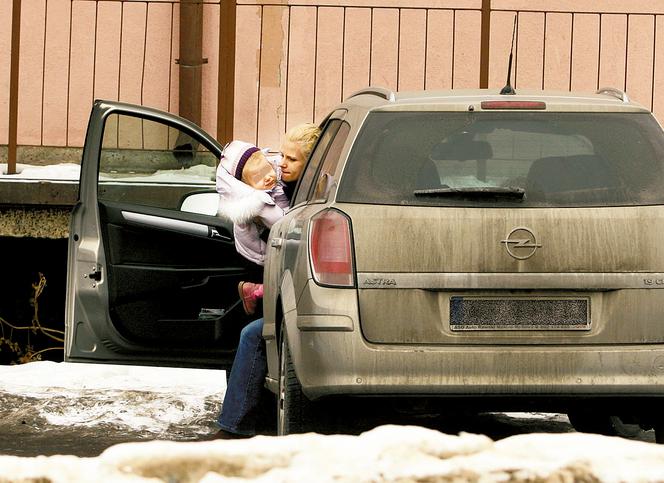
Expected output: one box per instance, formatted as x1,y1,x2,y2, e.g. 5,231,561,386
217,0,237,144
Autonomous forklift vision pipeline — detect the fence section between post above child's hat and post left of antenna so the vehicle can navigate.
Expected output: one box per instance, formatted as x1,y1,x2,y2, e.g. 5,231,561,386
234,2,482,149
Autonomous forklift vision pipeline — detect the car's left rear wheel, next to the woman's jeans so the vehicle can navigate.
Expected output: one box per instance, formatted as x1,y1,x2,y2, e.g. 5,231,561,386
277,329,314,436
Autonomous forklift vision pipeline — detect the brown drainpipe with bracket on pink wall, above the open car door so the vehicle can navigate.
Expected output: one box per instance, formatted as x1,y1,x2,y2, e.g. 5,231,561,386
176,0,207,124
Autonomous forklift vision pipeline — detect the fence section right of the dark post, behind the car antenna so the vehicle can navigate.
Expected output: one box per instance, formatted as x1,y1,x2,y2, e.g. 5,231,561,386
491,2,664,114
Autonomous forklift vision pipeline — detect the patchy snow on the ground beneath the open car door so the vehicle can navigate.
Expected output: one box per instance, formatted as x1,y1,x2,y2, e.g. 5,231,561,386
0,361,226,434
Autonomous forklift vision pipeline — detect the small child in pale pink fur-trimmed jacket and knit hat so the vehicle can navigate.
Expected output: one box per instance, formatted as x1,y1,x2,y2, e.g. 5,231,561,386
216,141,288,314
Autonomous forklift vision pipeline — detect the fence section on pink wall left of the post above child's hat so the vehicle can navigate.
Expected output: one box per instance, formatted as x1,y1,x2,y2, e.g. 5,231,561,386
0,0,219,146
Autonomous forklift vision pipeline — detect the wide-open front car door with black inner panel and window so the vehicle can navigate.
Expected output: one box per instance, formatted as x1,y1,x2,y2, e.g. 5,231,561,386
65,101,262,368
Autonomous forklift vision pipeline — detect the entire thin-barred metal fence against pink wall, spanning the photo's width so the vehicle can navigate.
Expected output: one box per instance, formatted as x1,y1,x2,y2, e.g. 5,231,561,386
0,0,664,163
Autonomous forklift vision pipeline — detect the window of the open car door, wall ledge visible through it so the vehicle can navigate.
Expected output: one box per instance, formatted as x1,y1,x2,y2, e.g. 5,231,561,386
98,113,217,210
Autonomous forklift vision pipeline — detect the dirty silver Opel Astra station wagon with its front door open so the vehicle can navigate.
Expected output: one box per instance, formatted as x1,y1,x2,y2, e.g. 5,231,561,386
66,88,664,440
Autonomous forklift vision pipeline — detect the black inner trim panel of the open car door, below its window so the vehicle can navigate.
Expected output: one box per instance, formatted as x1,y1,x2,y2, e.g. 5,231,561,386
100,203,262,350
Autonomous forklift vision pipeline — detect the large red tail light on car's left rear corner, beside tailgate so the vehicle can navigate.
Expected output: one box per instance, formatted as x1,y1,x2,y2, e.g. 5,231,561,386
309,210,354,287
